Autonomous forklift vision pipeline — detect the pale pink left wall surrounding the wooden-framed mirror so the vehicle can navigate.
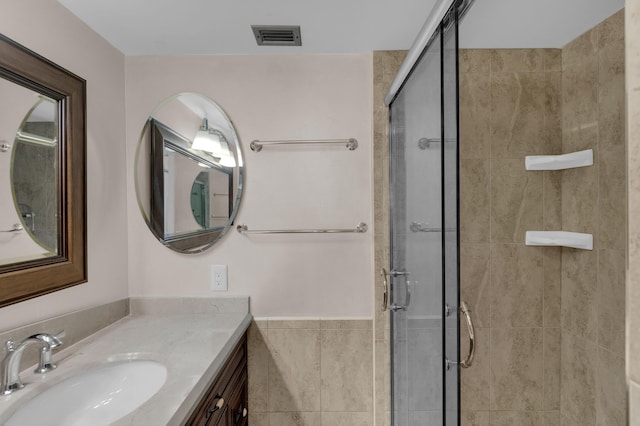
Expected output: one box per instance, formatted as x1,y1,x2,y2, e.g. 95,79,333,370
0,0,128,330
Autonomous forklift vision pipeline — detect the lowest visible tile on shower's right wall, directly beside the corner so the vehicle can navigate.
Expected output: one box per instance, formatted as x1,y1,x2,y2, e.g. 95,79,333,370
560,330,598,426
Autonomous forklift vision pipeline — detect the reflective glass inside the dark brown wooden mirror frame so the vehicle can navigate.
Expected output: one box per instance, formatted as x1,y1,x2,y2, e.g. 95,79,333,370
0,80,59,265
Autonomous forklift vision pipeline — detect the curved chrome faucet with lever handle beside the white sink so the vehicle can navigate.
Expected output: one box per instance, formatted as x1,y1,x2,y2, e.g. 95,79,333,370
1,333,62,395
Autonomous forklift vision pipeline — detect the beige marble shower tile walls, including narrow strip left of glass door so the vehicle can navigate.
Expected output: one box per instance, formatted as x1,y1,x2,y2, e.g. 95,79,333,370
374,10,624,425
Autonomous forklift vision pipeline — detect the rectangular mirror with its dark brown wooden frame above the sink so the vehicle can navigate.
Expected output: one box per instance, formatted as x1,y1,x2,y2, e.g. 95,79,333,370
0,34,87,306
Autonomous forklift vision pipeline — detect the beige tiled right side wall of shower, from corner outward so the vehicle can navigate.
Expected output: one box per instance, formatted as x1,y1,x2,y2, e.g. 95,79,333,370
560,10,627,426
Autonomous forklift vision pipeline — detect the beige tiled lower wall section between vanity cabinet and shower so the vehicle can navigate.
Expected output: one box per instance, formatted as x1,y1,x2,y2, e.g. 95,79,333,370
248,319,374,426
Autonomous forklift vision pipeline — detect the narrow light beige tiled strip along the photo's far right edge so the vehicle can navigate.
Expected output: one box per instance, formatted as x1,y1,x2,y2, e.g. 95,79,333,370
625,0,640,426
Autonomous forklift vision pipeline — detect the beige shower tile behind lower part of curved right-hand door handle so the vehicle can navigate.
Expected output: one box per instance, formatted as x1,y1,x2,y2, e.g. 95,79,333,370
460,328,491,411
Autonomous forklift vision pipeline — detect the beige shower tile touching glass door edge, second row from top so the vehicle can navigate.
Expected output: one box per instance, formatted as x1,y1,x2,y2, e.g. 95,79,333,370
460,72,491,160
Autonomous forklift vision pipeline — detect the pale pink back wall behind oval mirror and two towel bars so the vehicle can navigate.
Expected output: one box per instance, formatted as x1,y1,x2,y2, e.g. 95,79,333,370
126,54,373,317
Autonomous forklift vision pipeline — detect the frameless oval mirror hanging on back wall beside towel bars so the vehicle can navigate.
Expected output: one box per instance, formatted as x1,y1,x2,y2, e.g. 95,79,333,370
135,93,243,253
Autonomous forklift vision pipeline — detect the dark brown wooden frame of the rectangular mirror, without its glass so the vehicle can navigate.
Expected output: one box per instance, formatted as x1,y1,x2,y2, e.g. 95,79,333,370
0,34,88,307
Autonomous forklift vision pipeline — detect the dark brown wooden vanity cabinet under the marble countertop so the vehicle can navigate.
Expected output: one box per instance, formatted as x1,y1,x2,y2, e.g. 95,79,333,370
185,333,248,426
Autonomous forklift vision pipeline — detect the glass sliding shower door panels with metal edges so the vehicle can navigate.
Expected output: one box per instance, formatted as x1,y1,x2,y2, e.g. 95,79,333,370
385,1,473,426
